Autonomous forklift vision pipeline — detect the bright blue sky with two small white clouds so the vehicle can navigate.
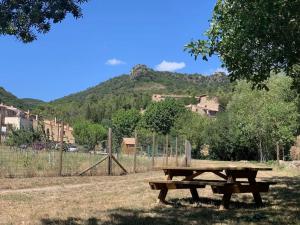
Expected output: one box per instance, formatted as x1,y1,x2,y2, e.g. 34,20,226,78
0,0,220,101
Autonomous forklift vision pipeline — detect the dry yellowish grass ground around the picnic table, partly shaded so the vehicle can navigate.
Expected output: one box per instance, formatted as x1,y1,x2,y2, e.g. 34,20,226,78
0,162,300,225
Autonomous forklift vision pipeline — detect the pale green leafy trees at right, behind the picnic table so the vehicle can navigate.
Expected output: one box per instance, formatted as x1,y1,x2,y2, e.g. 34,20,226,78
207,76,299,160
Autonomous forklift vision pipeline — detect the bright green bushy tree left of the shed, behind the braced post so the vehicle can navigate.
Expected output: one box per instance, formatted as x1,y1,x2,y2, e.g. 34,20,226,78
73,121,107,150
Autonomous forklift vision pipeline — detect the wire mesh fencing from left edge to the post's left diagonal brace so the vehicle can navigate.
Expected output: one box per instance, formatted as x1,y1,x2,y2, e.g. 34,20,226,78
0,146,104,177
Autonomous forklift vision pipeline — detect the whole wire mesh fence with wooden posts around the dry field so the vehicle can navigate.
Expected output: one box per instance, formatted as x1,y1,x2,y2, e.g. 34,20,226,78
0,129,190,177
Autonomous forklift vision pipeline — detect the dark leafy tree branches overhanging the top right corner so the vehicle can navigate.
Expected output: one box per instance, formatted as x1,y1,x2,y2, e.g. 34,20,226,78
186,0,300,91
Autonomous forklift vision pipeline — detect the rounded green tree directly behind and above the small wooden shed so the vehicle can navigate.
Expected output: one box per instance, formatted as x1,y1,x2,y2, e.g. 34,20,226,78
112,109,141,142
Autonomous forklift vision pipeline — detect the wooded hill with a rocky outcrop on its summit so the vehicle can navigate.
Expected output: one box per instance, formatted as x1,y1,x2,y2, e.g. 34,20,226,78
38,65,232,123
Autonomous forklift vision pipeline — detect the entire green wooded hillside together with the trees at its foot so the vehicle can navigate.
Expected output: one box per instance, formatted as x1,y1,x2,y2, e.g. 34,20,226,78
0,65,299,161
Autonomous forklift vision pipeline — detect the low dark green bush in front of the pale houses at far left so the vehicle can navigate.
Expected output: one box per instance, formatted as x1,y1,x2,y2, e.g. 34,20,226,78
6,129,43,147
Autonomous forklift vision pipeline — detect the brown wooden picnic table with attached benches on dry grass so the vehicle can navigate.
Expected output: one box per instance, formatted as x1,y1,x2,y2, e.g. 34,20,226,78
149,166,275,208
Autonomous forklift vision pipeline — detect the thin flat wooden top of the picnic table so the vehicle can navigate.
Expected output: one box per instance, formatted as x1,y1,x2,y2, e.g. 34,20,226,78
156,165,272,171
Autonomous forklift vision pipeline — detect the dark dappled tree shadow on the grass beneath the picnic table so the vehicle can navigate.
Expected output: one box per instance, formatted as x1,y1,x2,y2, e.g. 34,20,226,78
41,177,300,225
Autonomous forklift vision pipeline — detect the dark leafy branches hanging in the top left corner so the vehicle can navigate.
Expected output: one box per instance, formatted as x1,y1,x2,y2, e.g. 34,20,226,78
0,0,87,43
